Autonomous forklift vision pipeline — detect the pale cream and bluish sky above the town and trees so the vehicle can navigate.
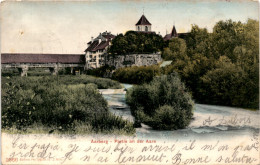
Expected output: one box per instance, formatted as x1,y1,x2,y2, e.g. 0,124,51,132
0,0,259,54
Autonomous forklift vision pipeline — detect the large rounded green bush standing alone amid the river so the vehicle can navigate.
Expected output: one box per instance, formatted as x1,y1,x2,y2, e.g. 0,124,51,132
126,74,193,130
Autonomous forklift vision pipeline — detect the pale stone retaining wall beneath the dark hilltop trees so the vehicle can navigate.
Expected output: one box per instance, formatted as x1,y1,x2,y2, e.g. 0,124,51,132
105,53,162,68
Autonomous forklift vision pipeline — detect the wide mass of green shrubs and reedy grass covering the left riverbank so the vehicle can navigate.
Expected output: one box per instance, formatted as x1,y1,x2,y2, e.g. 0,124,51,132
2,77,134,133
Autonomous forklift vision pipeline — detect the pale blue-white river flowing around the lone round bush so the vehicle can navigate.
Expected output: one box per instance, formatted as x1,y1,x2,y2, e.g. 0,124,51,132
100,84,259,139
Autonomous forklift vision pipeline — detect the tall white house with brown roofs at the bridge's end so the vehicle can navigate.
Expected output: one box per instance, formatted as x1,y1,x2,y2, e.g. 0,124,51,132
85,31,115,69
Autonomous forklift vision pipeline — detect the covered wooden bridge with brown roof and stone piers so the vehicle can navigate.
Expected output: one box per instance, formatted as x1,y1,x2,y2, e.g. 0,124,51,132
1,53,85,76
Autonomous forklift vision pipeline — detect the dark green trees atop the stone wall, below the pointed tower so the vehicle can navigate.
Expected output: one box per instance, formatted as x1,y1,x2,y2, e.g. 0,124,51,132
108,31,164,55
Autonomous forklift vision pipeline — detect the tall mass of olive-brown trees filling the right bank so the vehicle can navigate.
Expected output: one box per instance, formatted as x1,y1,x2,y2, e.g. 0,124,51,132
162,19,259,108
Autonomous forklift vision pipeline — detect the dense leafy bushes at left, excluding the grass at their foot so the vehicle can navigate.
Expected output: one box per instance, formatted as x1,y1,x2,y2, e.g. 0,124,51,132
2,81,108,129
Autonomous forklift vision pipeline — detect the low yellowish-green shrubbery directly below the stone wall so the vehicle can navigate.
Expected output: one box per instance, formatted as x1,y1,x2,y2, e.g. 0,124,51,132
112,65,160,84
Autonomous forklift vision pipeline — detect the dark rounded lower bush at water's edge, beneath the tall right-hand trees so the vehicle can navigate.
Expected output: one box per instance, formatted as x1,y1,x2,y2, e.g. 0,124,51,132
198,58,259,109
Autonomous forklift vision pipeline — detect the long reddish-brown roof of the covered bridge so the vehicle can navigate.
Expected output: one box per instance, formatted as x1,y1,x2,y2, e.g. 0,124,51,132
1,53,85,64
